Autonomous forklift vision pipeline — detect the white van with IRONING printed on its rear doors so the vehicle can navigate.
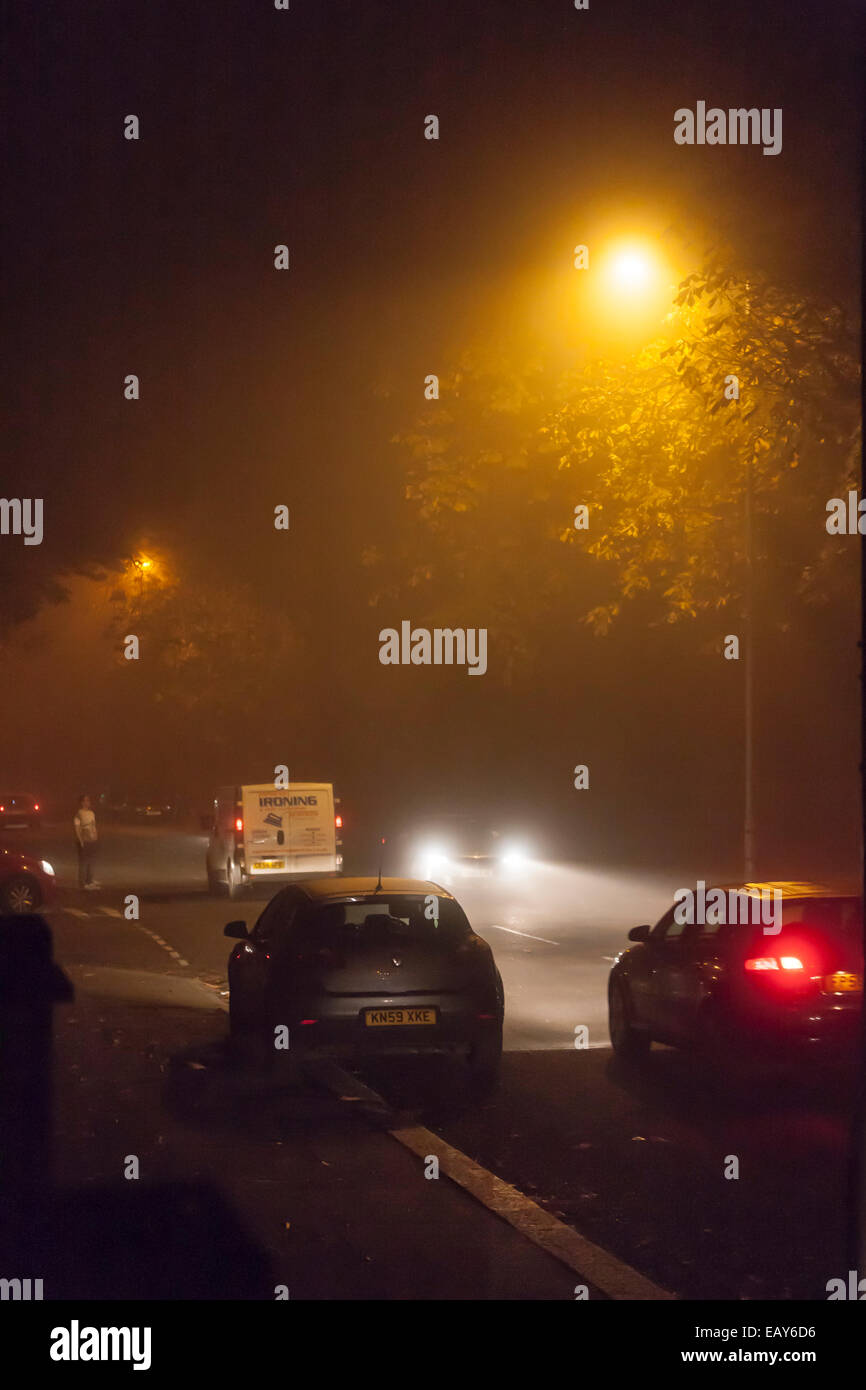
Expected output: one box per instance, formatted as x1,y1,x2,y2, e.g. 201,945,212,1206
207,783,343,898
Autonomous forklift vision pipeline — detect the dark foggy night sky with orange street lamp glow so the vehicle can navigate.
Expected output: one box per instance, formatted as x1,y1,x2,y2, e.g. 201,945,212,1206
0,0,862,877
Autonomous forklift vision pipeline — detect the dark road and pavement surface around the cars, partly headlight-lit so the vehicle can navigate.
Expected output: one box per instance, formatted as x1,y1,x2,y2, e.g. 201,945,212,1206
0,827,848,1300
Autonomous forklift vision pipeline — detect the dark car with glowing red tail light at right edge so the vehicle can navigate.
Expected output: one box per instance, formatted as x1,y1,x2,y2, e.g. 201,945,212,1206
607,883,863,1068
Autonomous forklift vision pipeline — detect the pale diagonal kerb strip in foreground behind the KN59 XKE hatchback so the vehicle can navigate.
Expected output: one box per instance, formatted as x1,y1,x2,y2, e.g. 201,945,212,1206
317,1066,677,1301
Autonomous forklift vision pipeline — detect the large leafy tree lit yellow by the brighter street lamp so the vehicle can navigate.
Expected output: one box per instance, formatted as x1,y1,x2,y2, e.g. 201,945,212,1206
398,252,859,652
